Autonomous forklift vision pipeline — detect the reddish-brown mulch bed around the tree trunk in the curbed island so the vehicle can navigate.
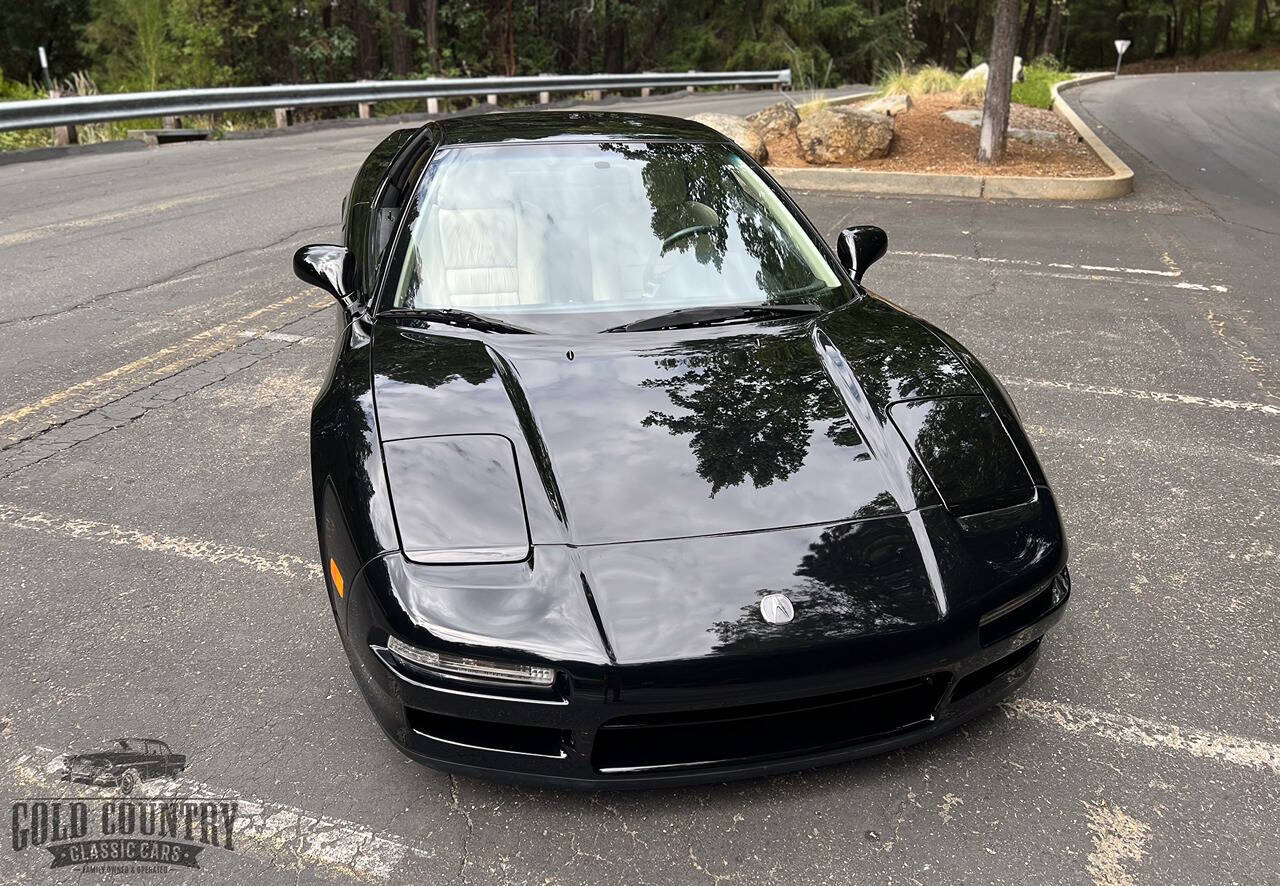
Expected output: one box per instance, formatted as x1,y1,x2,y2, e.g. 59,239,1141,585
769,92,1111,178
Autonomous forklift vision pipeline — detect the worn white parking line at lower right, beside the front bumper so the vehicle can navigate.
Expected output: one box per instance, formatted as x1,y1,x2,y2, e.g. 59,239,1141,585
1000,698,1280,775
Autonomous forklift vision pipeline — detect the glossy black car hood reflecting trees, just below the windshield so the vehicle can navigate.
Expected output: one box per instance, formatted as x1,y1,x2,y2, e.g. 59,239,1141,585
372,298,1030,549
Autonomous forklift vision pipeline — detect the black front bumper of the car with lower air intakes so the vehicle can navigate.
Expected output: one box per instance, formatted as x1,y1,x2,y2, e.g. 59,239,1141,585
339,560,1070,789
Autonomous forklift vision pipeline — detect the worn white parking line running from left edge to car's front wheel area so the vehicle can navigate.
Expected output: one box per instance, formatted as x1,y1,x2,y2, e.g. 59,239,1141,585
0,504,321,579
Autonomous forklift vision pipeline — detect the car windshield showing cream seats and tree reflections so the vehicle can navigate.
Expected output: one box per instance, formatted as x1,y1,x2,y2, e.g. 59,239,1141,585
393,142,841,328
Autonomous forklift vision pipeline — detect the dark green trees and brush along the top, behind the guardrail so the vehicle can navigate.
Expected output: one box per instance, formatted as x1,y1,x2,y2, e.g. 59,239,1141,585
0,0,1280,152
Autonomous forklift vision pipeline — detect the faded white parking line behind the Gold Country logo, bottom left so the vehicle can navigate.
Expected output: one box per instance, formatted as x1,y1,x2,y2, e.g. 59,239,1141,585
10,752,436,881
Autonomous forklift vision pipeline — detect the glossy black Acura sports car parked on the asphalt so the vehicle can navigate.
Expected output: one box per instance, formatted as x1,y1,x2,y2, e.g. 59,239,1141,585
294,113,1070,786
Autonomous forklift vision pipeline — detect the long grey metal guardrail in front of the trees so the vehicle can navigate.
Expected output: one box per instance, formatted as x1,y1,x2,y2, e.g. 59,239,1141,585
0,68,791,132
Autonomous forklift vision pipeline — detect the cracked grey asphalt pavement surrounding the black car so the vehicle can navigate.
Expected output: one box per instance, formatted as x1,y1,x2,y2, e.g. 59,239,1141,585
0,74,1280,886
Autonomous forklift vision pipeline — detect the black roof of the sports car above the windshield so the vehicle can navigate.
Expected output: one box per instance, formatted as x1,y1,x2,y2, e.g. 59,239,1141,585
434,111,728,145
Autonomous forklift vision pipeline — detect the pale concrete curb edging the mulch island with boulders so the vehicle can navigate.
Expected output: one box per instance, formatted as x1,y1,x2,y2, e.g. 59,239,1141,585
769,73,1133,200
